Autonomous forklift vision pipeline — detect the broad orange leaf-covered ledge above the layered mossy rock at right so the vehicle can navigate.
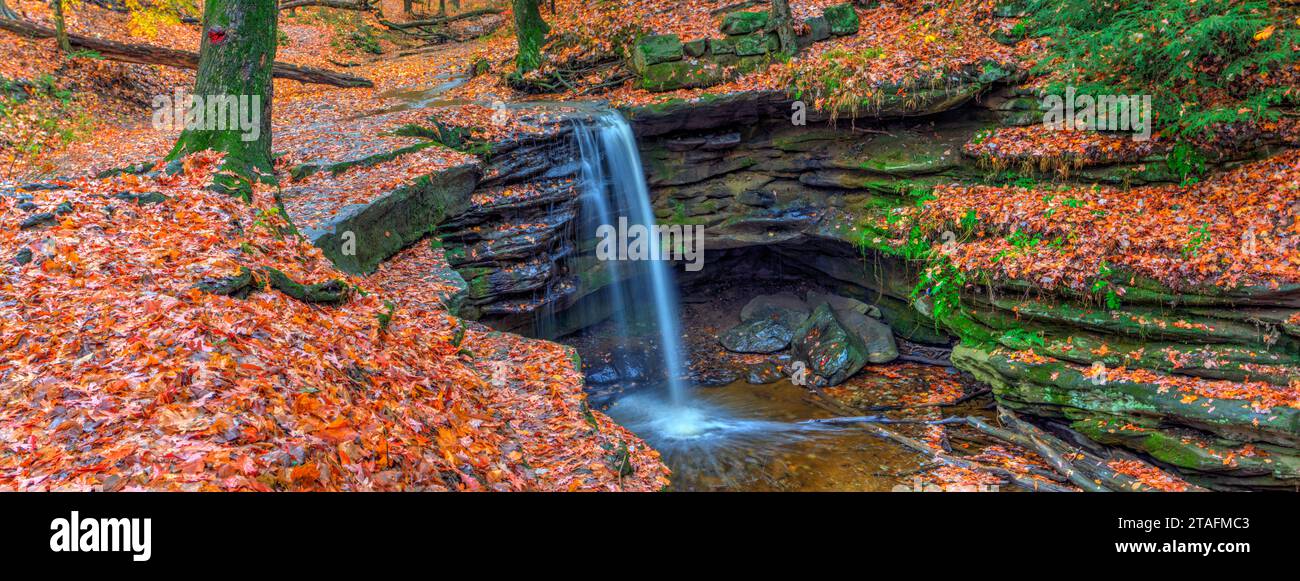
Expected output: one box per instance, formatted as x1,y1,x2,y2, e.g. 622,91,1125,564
904,149,1300,292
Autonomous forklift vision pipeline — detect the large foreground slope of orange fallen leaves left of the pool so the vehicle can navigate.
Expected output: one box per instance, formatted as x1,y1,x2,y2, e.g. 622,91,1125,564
0,156,667,490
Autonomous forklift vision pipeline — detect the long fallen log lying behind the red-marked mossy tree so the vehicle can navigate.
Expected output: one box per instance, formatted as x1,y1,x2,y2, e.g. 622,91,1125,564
0,18,374,88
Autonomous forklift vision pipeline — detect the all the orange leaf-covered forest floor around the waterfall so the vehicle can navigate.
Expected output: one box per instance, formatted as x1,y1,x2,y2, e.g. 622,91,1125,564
0,0,1300,490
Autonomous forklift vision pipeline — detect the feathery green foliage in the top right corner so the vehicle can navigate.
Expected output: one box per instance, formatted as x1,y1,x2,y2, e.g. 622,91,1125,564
1028,0,1300,140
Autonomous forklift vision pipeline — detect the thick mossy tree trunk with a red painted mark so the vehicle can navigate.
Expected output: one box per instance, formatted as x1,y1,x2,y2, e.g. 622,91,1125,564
168,0,280,200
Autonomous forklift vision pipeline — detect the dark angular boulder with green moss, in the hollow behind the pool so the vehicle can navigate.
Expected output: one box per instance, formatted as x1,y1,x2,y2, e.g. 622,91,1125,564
792,304,868,386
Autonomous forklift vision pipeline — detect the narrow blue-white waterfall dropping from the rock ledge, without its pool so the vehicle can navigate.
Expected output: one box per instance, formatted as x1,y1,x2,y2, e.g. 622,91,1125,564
575,109,685,404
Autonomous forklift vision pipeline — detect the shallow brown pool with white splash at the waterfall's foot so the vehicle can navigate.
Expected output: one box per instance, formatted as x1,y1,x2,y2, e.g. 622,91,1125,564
606,380,924,491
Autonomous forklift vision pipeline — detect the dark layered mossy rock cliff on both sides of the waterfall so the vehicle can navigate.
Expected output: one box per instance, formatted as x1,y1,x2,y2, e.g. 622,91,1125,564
441,91,1300,487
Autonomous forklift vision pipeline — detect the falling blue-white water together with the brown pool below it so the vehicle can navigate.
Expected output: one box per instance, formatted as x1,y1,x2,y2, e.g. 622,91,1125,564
564,110,930,490
